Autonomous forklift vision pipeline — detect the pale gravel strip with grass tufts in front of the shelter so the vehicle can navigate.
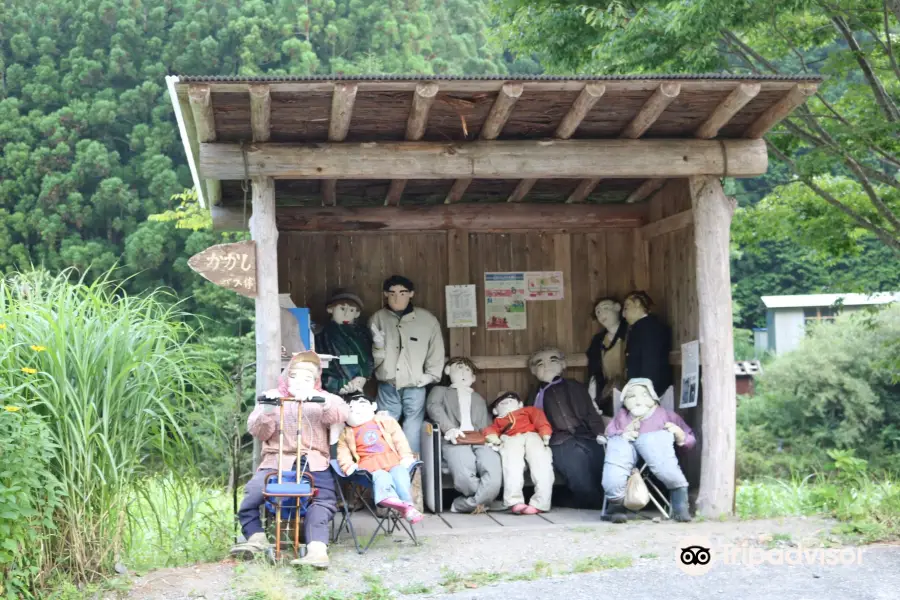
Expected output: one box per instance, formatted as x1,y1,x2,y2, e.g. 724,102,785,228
129,518,833,600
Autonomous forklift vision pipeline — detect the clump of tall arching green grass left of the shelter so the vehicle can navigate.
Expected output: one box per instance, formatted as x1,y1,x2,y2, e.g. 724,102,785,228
0,271,236,581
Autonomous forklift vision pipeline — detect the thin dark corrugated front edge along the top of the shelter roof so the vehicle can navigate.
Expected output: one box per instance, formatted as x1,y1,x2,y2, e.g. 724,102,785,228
178,73,823,83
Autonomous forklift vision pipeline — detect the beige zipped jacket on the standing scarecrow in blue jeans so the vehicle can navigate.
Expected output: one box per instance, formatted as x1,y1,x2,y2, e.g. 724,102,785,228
369,307,445,389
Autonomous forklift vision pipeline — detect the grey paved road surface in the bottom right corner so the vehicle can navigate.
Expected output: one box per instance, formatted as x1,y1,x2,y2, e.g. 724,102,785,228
433,546,900,600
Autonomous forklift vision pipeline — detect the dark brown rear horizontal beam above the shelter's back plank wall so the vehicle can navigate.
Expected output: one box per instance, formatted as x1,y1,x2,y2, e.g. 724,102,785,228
216,202,647,232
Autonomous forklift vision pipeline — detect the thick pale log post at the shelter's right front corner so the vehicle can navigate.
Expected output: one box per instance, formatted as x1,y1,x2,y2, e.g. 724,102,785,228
688,177,737,518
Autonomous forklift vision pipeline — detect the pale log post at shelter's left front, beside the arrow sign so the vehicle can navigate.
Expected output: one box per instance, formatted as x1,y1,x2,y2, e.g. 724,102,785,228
250,178,281,469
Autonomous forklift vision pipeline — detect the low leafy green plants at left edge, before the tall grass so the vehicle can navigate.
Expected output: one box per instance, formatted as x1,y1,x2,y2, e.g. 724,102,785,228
0,406,62,600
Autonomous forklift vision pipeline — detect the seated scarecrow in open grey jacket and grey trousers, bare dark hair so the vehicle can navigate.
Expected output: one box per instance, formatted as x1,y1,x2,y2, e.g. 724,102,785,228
427,357,503,513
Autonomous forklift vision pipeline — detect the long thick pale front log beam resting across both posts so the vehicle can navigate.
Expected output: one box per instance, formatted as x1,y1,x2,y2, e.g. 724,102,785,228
199,139,768,180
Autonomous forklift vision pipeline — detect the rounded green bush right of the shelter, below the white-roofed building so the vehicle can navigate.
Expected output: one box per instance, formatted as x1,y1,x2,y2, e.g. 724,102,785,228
738,306,900,478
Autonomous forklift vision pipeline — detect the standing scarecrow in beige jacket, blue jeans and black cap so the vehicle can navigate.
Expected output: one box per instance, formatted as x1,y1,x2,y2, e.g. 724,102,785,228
369,275,444,455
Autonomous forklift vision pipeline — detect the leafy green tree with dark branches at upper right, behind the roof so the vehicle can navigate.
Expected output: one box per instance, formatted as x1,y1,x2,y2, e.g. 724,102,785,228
495,0,900,255
